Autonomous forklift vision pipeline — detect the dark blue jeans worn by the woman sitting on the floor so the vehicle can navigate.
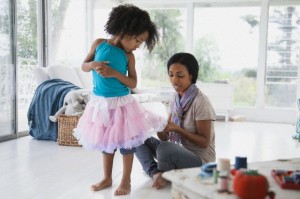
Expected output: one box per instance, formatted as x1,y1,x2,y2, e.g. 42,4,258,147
135,137,202,178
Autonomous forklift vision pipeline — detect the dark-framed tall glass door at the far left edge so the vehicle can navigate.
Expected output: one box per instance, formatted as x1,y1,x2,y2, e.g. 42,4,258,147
0,0,38,140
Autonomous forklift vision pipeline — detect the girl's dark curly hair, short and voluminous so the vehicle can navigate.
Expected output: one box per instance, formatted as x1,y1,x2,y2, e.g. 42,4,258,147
104,4,159,51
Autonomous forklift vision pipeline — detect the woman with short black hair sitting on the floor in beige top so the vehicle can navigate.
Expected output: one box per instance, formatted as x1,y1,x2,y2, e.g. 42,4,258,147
135,53,216,189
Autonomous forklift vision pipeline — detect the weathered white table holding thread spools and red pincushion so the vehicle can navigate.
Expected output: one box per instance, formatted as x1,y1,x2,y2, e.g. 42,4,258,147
163,158,300,199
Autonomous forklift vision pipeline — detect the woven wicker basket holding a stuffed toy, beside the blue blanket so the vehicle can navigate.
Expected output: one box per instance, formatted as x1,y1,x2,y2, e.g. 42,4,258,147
57,115,81,146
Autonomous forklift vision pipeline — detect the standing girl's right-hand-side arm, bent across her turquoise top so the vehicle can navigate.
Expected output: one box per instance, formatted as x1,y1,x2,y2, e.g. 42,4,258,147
96,53,137,88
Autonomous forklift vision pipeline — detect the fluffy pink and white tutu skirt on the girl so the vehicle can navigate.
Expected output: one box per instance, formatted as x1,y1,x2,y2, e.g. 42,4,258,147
73,95,167,153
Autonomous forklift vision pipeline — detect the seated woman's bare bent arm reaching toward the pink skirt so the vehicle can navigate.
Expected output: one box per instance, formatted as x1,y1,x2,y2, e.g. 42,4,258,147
164,120,212,148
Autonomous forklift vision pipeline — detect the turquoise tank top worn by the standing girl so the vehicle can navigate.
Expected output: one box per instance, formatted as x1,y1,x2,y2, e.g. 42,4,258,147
92,41,130,97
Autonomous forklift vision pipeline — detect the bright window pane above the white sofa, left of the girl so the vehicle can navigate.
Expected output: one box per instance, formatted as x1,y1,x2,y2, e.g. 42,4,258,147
48,0,88,67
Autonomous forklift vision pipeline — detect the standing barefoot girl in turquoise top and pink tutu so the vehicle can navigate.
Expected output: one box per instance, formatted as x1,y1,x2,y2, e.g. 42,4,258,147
74,5,166,195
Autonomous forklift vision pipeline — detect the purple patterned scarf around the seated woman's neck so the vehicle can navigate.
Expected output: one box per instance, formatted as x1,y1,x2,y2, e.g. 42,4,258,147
169,84,199,144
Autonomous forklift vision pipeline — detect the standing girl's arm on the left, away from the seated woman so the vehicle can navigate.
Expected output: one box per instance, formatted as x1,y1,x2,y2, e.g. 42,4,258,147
81,39,105,72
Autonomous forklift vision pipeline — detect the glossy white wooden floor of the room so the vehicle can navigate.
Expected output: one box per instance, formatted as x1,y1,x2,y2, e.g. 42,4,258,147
0,121,300,199
